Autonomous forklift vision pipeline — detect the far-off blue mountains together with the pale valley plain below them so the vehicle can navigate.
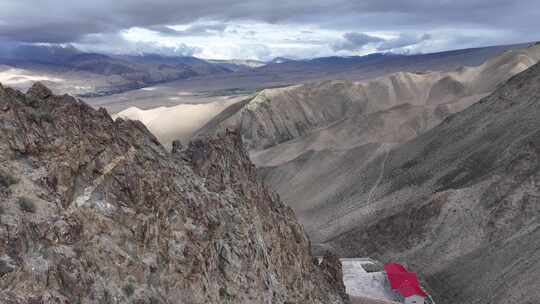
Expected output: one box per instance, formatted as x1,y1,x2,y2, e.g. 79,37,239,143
0,44,526,113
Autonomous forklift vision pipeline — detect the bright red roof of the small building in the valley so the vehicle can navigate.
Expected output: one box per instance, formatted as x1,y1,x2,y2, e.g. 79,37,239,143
384,263,428,304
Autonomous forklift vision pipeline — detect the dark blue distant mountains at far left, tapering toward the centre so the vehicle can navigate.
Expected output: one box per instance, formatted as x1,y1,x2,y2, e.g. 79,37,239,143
0,46,232,97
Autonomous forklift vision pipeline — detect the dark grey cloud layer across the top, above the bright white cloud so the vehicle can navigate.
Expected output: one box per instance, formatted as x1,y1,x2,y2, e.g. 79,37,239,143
0,0,540,42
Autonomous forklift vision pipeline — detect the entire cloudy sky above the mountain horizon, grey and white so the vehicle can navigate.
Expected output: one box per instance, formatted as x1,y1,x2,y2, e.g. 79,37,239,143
0,0,540,60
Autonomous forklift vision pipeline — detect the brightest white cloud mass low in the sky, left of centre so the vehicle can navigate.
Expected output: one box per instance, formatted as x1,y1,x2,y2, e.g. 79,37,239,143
75,20,348,60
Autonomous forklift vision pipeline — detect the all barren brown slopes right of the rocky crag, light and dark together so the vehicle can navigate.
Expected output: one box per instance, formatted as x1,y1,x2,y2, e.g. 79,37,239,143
192,46,540,303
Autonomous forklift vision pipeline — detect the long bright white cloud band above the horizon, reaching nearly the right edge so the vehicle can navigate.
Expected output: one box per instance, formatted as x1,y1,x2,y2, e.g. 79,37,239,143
66,20,532,60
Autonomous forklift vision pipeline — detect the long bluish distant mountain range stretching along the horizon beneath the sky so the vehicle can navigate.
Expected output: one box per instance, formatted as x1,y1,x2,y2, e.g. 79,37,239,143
0,41,524,97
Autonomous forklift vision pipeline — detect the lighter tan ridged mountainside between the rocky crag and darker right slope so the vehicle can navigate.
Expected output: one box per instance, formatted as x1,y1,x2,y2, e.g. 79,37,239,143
198,46,540,243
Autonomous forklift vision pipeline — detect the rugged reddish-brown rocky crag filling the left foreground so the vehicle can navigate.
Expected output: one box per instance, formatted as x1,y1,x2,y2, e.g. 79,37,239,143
0,84,345,304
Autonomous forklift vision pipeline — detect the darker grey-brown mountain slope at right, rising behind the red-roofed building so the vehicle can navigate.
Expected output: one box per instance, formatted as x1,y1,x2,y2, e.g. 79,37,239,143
324,64,540,304
